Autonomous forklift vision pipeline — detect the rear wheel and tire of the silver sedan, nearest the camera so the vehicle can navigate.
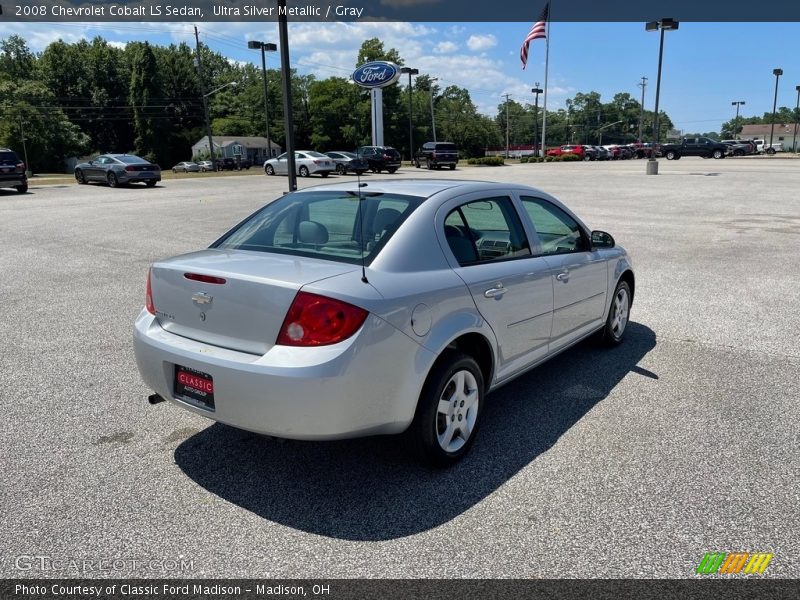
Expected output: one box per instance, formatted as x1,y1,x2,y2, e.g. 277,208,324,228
408,352,485,467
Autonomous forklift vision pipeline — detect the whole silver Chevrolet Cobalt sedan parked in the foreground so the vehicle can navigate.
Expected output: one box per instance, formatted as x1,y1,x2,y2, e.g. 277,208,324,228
134,180,634,465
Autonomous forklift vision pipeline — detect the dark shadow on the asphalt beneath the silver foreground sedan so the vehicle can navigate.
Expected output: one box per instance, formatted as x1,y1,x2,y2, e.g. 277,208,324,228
175,323,658,541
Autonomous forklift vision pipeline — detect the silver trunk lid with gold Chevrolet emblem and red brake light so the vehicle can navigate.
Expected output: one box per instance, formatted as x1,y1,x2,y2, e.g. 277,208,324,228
150,249,356,355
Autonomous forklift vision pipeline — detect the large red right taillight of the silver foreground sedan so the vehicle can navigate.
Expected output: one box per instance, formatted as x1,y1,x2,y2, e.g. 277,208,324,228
275,292,369,346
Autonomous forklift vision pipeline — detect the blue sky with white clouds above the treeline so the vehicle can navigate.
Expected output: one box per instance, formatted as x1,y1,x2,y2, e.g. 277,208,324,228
0,16,800,132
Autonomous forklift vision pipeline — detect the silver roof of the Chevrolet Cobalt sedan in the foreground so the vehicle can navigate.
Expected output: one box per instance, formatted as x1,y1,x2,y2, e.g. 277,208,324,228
295,179,550,198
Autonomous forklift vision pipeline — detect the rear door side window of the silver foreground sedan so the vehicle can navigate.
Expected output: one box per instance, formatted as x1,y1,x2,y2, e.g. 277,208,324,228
444,197,531,267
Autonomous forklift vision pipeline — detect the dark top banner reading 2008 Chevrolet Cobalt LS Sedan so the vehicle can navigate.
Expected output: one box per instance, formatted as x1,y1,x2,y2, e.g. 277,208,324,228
0,0,800,23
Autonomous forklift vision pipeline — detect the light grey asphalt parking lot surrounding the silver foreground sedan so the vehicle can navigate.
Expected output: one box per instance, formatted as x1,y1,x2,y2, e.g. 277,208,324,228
0,158,800,578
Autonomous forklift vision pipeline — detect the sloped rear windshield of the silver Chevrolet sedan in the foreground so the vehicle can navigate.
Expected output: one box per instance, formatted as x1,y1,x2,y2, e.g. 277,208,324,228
211,191,424,264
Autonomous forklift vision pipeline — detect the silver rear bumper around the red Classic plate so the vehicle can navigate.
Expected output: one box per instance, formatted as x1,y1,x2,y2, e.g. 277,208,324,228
138,311,436,440
